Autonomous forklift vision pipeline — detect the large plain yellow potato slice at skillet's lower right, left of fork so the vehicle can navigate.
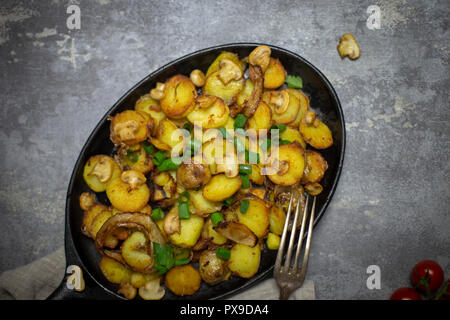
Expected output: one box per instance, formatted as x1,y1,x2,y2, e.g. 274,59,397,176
228,243,261,279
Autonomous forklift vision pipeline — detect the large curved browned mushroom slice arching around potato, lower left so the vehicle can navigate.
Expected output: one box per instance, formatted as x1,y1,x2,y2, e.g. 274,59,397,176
95,213,166,273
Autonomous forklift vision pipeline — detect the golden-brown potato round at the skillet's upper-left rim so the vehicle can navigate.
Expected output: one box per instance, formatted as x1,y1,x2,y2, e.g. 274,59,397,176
110,110,154,146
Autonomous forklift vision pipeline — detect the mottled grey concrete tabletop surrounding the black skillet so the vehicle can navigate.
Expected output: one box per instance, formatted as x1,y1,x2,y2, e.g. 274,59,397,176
0,0,450,299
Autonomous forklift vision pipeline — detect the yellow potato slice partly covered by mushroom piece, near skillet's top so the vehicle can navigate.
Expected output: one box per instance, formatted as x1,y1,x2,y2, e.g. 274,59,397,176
203,71,244,105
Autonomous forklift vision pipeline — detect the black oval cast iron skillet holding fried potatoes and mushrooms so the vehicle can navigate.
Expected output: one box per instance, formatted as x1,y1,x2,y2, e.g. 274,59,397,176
49,43,345,299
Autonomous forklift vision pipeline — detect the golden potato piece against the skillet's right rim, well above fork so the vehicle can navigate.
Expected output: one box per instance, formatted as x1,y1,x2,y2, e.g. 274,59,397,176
299,114,333,150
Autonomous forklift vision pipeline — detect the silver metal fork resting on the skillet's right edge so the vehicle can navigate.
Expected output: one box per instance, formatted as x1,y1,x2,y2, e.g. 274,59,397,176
273,194,316,300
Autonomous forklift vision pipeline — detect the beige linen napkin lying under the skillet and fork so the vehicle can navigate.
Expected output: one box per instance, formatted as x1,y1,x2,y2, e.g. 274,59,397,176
0,247,315,300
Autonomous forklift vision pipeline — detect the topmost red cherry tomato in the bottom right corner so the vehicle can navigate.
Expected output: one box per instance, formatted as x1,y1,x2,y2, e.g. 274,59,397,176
411,260,444,294
